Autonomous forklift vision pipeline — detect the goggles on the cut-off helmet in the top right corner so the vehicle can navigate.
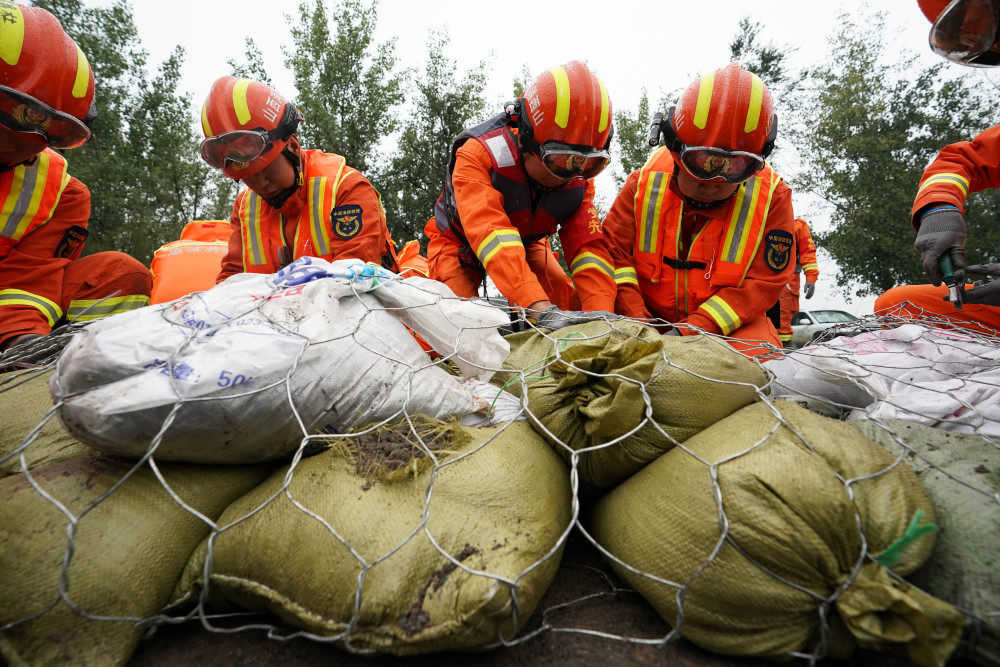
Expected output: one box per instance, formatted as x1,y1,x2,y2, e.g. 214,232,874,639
928,0,1000,67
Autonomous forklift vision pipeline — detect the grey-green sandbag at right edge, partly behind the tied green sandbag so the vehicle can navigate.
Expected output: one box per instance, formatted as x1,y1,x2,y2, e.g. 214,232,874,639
848,419,1000,667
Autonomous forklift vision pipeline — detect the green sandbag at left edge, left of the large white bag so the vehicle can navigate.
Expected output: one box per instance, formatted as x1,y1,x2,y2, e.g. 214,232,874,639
0,369,98,477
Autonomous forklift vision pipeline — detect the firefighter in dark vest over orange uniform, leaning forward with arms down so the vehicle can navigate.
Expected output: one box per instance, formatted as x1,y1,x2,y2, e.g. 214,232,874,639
424,61,615,328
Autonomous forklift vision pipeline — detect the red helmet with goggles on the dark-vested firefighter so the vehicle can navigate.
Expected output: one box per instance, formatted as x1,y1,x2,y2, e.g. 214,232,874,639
510,60,613,178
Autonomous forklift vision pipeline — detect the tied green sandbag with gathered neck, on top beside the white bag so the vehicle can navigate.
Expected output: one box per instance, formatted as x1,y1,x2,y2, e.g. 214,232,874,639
494,321,767,487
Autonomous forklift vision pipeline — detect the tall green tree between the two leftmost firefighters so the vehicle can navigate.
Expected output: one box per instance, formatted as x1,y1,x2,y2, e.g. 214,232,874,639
37,0,231,263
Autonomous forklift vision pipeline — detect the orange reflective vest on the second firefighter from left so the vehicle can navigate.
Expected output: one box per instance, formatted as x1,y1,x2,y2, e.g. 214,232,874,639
237,151,396,273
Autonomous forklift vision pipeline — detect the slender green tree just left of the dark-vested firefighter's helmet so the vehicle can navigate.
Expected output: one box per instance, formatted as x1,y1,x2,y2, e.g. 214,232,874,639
372,30,489,242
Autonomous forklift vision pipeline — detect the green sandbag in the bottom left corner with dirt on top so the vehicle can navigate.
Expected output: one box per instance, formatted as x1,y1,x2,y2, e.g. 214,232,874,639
0,456,269,665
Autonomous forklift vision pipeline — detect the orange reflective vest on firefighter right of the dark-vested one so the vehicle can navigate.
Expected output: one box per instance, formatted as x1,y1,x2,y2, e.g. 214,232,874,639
632,147,781,331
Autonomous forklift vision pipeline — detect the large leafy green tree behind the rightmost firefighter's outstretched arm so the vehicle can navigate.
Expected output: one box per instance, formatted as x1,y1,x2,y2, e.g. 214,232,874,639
796,9,1000,296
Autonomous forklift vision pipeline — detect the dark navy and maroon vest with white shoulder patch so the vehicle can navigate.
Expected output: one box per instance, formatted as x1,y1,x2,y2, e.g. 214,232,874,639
434,114,586,265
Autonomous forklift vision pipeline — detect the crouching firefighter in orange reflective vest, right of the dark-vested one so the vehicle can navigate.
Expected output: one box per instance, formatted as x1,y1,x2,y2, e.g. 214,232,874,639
604,63,795,355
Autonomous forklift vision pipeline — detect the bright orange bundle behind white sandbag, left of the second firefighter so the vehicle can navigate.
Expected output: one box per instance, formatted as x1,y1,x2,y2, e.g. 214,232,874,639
149,220,233,304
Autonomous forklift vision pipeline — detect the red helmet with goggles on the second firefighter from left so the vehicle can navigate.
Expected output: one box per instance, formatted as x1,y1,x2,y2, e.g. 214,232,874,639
201,76,304,180
